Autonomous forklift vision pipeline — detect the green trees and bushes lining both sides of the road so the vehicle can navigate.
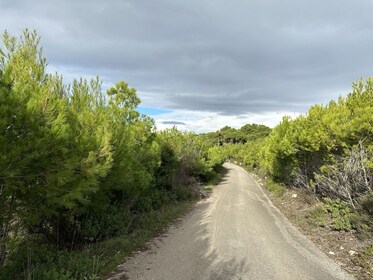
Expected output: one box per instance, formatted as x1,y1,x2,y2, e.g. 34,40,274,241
0,30,373,279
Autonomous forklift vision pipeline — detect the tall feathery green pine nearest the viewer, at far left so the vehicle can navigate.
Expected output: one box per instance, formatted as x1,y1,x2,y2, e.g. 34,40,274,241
0,31,112,248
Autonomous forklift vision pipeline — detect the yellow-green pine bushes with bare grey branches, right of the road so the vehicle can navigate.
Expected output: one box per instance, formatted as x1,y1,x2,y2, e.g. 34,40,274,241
256,78,373,206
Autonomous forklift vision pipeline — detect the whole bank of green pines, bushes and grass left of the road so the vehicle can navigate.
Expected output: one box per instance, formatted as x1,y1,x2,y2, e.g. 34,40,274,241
0,30,222,280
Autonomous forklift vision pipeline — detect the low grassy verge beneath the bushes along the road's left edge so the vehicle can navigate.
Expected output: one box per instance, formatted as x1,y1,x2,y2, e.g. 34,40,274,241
0,202,191,280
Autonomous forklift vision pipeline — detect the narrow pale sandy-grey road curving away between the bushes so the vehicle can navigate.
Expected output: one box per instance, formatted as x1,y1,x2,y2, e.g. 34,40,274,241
110,164,353,280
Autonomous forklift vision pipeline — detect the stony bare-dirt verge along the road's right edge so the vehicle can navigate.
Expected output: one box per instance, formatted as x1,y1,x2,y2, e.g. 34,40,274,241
255,176,373,280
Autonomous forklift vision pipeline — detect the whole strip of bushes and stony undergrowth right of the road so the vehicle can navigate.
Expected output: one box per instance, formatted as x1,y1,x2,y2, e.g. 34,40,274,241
204,78,373,279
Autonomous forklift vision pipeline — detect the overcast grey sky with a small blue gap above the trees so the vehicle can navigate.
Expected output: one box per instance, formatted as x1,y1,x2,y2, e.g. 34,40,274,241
0,0,373,132
